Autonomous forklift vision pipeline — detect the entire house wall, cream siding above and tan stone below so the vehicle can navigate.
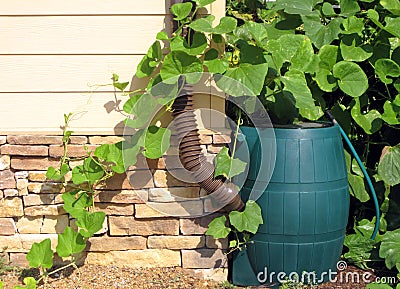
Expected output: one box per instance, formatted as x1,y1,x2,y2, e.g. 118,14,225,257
0,0,227,280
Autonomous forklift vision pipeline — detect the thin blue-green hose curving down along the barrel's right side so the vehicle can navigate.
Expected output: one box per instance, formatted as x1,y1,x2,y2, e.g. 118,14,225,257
326,111,381,240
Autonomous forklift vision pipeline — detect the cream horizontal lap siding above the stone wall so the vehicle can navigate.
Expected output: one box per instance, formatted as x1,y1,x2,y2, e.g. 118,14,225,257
0,0,225,134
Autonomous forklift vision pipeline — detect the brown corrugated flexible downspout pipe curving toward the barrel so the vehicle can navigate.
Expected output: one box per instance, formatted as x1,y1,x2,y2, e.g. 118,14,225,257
172,85,244,211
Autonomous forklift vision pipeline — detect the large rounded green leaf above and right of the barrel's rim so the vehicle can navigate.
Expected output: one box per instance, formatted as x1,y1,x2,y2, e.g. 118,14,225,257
333,61,368,97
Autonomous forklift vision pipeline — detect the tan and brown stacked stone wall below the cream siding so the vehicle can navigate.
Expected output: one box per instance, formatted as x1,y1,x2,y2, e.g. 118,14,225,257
0,131,228,280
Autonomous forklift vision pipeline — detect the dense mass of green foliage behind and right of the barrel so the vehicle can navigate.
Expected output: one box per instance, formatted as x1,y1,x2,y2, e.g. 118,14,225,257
220,0,400,276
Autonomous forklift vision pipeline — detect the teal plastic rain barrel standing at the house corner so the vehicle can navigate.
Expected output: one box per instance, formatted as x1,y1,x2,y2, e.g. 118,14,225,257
232,124,350,286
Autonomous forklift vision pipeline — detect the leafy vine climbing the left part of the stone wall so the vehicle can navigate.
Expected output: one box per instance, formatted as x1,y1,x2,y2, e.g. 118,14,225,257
23,111,120,289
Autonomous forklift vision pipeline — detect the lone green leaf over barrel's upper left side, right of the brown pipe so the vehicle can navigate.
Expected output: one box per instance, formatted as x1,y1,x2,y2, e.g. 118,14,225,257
214,147,247,178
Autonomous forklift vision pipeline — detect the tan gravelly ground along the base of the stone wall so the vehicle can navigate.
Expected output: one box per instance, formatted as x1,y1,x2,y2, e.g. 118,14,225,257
0,265,382,289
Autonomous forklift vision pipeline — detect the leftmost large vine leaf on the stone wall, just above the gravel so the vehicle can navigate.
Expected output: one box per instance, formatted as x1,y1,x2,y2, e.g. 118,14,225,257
26,239,54,268
